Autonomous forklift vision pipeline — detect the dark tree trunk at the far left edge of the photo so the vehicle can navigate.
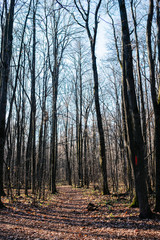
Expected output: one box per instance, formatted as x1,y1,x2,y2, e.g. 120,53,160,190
0,0,15,207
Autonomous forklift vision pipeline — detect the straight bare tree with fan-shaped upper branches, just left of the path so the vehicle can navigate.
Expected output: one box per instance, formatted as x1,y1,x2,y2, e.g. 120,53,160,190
45,0,71,193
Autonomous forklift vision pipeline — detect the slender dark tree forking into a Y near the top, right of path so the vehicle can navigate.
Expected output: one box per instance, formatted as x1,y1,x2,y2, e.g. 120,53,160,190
71,0,109,194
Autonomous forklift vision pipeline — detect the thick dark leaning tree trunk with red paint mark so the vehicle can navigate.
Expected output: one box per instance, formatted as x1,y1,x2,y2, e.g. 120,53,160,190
118,0,151,218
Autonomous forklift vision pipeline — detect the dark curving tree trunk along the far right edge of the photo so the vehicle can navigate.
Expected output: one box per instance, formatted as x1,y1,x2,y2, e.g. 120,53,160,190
146,0,160,212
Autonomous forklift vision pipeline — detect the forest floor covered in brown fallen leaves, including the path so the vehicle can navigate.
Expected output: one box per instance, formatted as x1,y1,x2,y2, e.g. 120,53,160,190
0,186,160,240
